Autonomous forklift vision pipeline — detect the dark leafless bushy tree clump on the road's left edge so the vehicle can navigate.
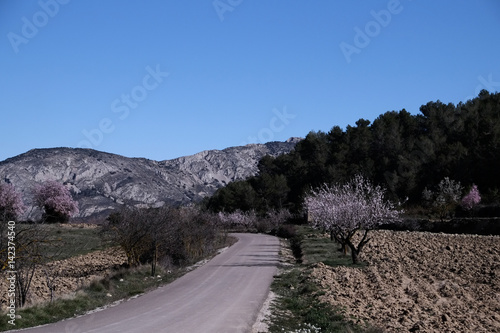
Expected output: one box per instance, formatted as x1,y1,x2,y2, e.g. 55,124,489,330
103,206,219,275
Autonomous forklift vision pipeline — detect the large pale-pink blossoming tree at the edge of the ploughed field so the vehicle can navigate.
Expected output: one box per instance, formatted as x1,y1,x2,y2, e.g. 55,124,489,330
305,175,400,263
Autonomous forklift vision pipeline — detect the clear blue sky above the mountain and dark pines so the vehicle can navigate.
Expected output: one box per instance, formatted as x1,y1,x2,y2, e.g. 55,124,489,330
0,0,500,160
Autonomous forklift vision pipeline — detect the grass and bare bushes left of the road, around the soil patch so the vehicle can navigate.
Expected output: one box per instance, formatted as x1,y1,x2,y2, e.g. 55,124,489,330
0,207,234,331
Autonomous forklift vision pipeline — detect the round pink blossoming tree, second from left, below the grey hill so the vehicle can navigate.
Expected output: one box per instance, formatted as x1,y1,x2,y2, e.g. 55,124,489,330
34,180,78,222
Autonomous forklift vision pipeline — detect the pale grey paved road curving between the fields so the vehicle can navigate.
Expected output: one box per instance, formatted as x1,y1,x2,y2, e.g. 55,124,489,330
18,234,279,333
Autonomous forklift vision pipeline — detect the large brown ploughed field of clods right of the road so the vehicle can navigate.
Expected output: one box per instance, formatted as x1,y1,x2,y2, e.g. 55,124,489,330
311,231,500,333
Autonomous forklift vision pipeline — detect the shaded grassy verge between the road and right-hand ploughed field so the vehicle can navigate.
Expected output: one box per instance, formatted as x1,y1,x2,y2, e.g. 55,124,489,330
269,225,383,333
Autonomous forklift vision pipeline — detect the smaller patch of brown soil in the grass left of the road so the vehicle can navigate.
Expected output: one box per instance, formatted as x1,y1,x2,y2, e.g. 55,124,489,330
0,248,127,308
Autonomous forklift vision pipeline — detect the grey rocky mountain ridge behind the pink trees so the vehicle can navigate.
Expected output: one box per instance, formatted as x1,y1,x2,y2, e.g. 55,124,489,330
0,138,300,219
